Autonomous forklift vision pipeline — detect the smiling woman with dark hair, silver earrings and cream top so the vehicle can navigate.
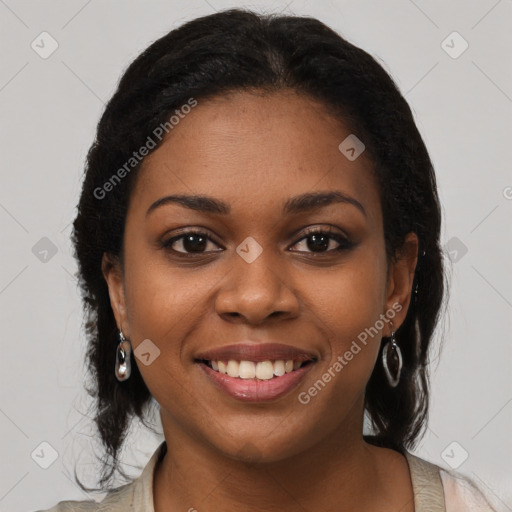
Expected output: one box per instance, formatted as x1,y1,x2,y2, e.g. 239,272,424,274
37,10,500,512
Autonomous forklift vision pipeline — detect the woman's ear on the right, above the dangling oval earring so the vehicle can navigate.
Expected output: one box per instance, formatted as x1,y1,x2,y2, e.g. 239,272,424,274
386,232,419,336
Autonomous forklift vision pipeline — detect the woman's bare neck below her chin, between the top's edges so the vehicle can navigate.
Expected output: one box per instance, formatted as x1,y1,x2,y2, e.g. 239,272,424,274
153,400,392,512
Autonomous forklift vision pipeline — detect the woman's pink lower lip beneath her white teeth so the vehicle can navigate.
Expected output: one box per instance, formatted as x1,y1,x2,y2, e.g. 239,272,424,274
198,363,314,402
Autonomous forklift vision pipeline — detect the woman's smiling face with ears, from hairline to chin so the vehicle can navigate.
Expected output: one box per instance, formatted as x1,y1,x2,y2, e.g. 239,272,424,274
104,92,416,461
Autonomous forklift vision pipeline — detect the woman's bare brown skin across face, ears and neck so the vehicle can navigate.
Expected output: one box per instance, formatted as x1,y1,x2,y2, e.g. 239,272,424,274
103,91,418,512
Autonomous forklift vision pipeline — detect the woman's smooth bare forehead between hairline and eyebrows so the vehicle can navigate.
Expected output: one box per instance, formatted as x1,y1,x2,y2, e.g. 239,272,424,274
131,91,380,224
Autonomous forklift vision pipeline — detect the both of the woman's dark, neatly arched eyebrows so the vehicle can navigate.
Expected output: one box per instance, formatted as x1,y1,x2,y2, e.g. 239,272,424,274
146,191,367,217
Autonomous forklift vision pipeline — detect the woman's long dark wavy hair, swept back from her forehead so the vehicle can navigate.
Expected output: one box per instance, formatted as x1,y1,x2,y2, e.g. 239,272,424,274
72,9,446,491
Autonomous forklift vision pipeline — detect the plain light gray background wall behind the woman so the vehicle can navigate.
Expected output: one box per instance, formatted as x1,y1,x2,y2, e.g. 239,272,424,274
0,0,512,512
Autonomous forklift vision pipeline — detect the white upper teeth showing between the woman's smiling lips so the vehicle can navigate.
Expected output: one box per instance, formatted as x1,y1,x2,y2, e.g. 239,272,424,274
196,359,314,380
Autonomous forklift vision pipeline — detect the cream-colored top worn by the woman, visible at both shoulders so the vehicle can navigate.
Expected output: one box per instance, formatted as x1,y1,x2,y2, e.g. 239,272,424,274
37,441,500,512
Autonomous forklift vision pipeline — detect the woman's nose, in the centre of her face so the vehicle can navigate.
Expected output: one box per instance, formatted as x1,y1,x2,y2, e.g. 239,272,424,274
215,250,299,324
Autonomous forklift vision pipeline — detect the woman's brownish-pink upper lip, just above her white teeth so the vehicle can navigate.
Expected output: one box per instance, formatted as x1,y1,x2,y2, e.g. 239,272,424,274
196,343,316,362
